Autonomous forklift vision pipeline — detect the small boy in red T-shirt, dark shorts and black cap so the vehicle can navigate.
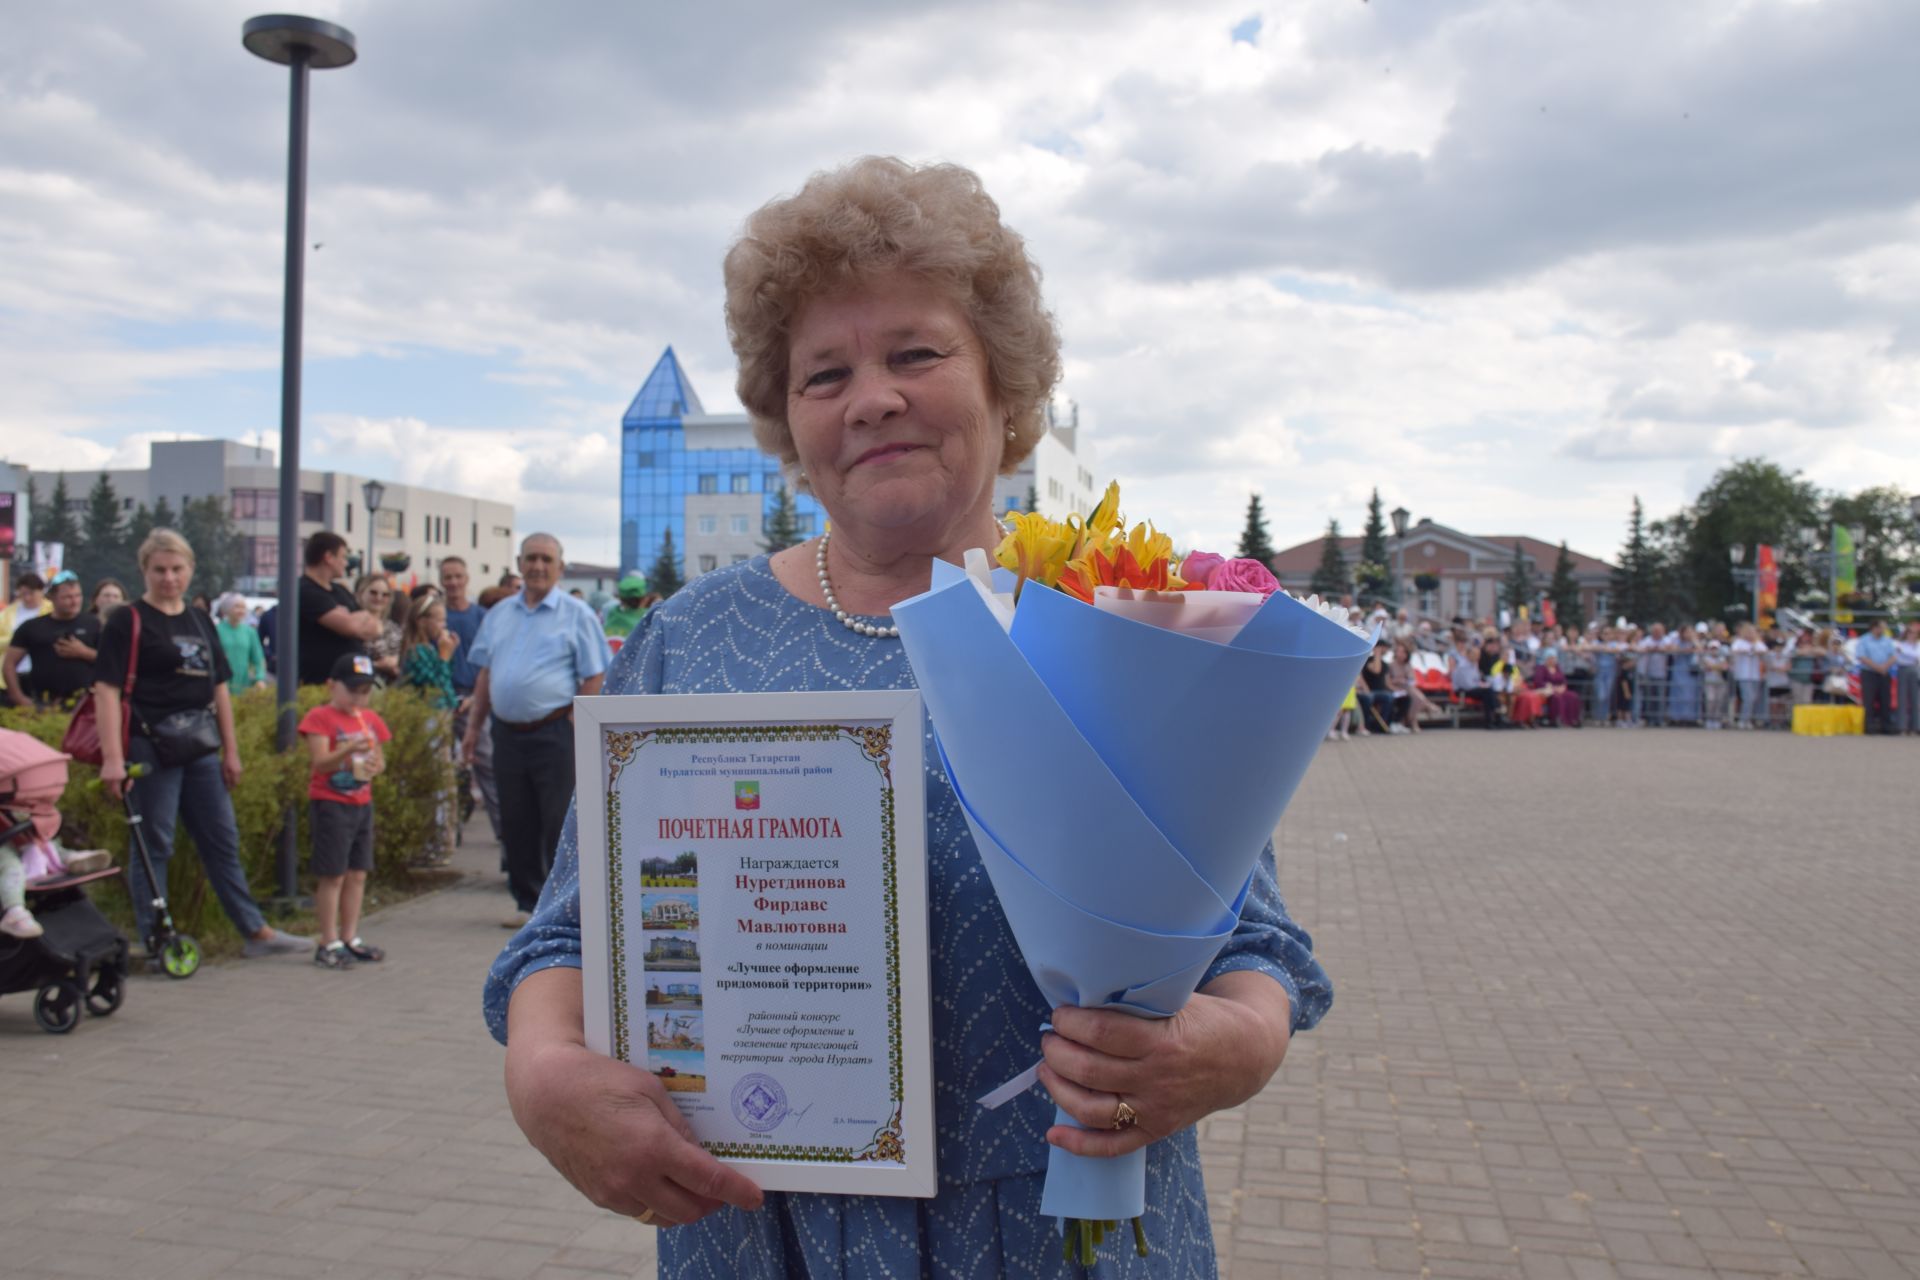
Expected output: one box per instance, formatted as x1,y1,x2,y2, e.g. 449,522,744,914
300,652,394,969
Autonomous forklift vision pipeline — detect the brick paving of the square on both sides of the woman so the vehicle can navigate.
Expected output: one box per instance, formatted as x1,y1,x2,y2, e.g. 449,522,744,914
0,731,1920,1280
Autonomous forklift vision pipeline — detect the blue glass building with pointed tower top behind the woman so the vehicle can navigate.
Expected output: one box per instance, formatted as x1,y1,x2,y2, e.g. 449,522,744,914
620,347,820,578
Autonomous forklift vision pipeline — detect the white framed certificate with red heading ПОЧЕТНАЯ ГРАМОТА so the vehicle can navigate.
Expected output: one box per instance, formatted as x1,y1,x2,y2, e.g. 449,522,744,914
574,689,937,1196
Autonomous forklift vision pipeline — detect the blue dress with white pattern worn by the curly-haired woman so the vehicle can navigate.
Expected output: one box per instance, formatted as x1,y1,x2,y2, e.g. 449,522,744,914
486,557,1332,1280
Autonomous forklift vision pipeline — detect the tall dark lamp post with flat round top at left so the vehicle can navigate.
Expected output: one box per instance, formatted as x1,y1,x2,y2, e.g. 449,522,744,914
240,13,357,900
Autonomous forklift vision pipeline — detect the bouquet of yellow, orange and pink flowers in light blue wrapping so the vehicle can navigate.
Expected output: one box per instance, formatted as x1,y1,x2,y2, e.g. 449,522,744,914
893,486,1371,1263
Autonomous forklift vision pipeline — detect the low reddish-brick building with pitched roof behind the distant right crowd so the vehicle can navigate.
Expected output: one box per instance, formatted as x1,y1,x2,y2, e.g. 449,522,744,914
1273,520,1613,620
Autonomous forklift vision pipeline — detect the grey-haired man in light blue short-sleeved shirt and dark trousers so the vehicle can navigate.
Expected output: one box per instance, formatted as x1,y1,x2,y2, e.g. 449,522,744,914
461,533,607,929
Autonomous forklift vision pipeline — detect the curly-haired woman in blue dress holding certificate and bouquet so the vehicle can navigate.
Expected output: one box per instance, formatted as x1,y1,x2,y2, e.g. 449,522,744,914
486,157,1332,1278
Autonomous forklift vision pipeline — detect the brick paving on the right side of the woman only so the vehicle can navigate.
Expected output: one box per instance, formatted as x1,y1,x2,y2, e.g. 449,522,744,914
1202,729,1920,1280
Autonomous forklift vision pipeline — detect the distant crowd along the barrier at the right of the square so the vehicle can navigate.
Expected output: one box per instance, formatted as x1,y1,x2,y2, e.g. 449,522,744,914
1329,608,1920,741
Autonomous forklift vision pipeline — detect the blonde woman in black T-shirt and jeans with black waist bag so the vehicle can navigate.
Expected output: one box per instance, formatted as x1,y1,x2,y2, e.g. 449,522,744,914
94,530,313,958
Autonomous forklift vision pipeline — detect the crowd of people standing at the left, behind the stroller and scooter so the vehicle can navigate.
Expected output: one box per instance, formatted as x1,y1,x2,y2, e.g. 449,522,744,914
0,530,614,969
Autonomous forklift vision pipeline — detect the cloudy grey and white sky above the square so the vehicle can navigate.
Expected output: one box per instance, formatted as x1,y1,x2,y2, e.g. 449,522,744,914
0,0,1920,571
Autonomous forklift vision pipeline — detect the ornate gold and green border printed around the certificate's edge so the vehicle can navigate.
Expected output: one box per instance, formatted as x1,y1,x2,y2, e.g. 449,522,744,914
605,722,906,1165
